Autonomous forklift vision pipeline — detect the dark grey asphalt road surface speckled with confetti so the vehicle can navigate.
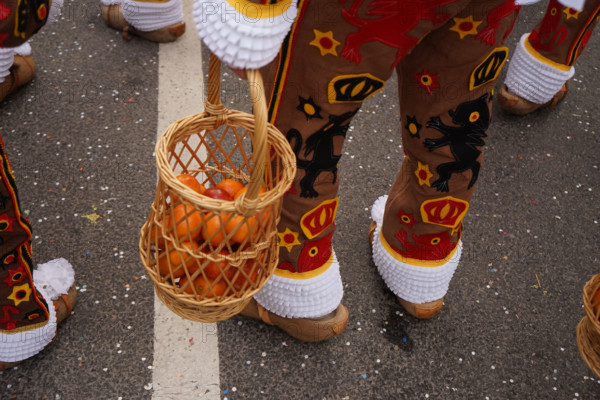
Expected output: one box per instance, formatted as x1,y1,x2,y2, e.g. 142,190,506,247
0,2,600,400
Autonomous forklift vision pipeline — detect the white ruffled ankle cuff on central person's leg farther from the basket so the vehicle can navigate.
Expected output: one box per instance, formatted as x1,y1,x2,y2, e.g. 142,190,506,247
371,196,462,304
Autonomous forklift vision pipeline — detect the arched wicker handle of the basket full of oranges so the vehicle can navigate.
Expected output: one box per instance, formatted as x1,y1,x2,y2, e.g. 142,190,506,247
204,53,267,208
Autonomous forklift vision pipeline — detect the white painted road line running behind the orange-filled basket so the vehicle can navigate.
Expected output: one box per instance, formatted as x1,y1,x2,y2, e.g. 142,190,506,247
152,0,220,400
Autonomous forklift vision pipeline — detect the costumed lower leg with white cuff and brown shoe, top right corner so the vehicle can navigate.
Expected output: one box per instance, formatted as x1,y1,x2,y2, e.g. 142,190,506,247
499,0,600,114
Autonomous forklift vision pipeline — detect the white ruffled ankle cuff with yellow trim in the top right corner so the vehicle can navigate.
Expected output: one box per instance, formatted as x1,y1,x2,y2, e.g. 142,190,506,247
504,34,575,104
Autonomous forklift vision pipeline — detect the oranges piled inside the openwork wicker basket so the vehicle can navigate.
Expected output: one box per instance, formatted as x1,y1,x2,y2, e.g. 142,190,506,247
151,173,270,298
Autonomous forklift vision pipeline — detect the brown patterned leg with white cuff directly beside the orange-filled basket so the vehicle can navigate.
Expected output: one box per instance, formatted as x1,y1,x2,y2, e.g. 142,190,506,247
248,0,474,318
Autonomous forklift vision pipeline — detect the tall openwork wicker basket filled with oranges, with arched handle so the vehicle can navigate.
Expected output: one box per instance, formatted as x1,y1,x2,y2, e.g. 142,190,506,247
139,55,296,322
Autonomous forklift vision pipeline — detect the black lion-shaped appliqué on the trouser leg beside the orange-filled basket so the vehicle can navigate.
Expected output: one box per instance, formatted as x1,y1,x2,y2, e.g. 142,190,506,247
286,108,358,197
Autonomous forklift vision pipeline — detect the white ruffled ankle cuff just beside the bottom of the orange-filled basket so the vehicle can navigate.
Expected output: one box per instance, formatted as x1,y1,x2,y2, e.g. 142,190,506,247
254,253,344,318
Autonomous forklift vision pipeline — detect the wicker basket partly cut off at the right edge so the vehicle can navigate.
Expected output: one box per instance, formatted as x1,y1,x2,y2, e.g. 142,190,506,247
577,274,600,378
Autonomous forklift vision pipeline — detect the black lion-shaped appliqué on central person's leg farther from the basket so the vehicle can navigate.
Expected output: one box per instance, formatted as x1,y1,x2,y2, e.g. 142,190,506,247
423,93,490,192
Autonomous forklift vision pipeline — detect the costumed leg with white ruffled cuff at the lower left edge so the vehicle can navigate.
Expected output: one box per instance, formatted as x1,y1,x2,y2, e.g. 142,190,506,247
0,141,74,369
